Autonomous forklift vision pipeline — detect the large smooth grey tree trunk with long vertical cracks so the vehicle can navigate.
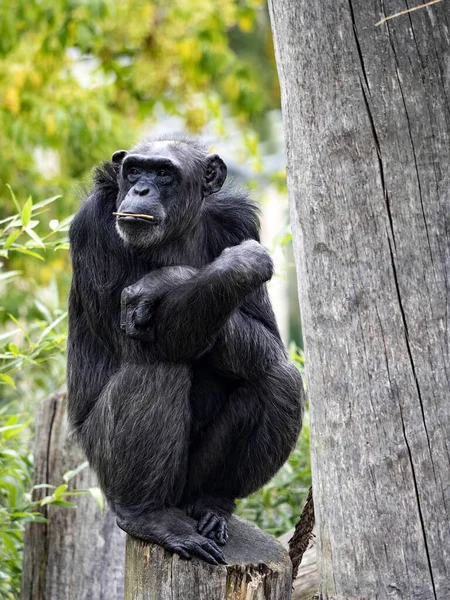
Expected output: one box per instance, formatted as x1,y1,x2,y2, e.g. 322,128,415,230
271,0,450,600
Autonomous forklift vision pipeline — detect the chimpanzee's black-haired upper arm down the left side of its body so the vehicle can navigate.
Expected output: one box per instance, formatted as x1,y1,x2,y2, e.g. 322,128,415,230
67,202,123,429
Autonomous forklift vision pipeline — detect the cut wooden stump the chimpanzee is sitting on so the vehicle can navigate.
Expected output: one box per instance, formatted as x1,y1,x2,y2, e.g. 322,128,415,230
125,517,292,600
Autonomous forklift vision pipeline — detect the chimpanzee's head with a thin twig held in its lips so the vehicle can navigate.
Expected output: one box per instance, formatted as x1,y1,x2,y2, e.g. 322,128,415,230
112,140,227,248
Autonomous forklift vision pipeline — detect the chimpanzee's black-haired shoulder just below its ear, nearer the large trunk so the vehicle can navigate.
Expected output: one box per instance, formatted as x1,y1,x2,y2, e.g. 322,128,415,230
205,185,260,254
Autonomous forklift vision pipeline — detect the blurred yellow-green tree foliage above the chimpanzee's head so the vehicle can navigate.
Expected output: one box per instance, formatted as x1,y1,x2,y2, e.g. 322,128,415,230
0,0,278,203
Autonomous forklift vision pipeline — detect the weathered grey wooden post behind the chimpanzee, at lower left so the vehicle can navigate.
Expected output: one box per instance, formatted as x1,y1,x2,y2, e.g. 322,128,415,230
20,394,125,600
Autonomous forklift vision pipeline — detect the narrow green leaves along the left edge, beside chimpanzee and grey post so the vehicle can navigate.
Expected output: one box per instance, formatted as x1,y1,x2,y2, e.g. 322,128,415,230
0,196,103,600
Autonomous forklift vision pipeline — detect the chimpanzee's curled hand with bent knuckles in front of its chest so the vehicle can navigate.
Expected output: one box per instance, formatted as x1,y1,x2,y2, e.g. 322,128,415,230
120,266,196,342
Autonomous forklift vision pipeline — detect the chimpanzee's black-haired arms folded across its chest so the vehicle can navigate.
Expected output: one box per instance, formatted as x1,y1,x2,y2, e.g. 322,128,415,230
121,240,284,378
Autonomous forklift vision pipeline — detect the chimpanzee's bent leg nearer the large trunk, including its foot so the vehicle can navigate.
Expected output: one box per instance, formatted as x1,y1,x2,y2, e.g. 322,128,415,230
183,360,303,544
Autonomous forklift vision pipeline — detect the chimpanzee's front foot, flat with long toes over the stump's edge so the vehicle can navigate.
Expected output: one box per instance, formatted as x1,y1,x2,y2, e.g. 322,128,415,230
117,509,227,565
